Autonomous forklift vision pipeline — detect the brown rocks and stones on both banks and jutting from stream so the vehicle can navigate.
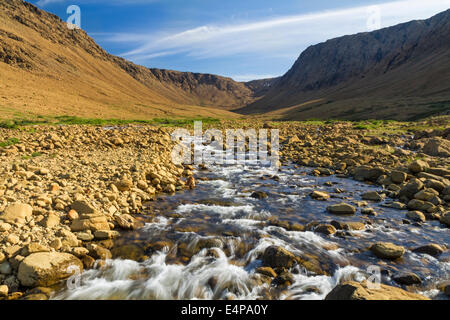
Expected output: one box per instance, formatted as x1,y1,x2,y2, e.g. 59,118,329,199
0,121,450,299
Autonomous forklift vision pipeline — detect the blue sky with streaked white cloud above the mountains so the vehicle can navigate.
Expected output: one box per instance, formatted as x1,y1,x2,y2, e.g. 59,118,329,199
29,0,450,81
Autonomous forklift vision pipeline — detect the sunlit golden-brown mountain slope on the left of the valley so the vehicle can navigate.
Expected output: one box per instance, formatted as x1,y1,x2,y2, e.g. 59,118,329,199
0,0,255,118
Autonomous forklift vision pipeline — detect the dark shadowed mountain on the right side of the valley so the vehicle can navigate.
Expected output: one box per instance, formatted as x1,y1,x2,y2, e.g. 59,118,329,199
237,10,450,120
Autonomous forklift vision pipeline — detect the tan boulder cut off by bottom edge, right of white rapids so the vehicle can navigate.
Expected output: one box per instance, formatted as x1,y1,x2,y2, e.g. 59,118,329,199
325,281,430,300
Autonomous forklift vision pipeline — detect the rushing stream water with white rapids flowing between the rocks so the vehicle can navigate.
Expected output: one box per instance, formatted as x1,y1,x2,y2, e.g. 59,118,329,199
54,150,450,299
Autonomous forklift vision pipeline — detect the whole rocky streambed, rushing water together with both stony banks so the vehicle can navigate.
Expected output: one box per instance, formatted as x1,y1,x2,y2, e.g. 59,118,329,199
0,124,450,299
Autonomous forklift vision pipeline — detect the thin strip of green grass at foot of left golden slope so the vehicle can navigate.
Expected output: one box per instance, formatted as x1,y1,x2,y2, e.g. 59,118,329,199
0,116,220,131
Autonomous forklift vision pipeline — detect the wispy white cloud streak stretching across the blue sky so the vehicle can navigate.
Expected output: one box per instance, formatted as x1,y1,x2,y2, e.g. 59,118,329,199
98,0,450,62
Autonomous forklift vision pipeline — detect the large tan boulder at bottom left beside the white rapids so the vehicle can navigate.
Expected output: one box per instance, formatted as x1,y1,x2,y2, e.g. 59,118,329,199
17,252,83,287
